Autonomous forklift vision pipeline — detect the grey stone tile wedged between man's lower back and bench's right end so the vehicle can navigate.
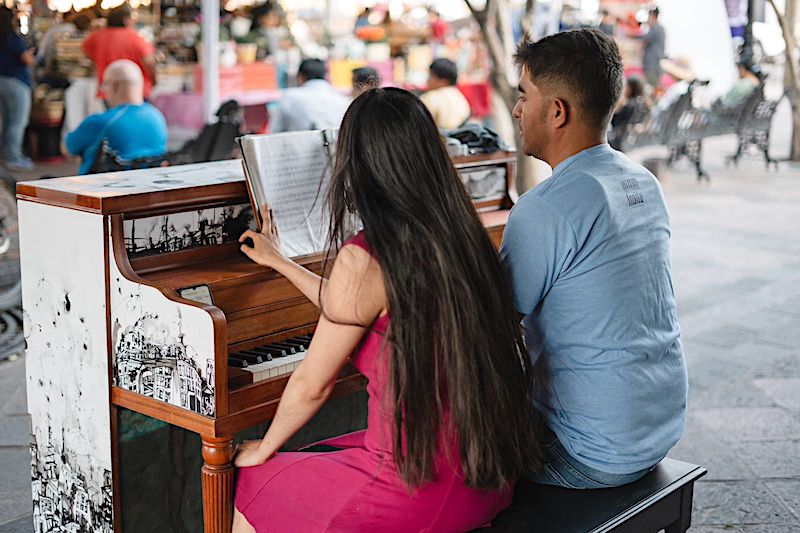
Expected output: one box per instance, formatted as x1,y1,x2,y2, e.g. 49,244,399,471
669,415,753,481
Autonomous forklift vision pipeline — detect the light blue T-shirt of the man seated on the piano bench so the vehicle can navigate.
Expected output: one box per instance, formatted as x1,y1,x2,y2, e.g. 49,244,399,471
500,144,688,474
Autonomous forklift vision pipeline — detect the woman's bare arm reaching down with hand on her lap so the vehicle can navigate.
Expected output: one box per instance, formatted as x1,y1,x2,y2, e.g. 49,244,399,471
235,245,386,466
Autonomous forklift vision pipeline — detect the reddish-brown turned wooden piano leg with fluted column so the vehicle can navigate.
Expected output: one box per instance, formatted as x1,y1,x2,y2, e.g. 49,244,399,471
201,436,233,533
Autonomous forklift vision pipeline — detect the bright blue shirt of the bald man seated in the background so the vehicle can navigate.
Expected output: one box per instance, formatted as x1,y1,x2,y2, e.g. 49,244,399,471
64,102,167,174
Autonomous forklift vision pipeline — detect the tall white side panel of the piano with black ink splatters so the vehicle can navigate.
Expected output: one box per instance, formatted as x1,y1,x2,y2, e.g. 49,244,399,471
19,202,113,532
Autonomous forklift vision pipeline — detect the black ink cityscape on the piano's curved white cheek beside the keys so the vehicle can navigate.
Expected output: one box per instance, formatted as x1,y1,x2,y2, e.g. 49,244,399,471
114,313,214,416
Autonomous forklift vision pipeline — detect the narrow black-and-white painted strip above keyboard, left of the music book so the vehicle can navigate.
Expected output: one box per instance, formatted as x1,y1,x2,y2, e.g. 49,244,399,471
124,204,255,256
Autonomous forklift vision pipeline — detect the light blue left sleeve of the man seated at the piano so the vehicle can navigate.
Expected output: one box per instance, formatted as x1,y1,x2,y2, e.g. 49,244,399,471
500,194,577,315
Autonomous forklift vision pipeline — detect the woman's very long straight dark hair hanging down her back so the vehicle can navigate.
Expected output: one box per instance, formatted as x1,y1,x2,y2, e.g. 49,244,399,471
323,88,540,489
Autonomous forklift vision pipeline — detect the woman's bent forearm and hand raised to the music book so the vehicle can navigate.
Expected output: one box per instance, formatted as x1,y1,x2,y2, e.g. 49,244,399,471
239,206,327,307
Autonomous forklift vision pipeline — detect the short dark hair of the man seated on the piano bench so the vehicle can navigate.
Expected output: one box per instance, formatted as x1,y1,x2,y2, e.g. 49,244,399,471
514,29,623,129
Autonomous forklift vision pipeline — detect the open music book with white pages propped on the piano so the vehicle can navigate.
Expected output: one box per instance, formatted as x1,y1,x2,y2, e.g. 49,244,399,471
239,129,339,257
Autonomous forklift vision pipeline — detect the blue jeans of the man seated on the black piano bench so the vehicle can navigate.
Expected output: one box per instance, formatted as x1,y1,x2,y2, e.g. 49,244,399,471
529,428,655,489
